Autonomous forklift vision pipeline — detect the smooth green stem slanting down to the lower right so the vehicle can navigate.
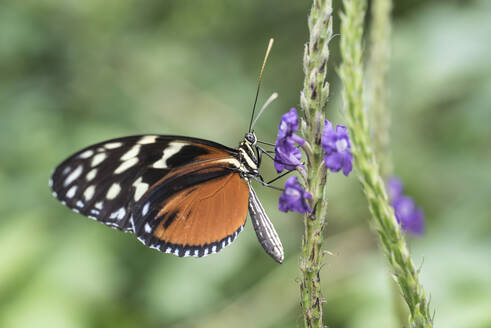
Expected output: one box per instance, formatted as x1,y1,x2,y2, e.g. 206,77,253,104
339,0,433,327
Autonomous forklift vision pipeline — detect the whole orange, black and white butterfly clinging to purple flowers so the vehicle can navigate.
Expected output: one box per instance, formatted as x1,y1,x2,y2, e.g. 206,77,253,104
49,41,284,263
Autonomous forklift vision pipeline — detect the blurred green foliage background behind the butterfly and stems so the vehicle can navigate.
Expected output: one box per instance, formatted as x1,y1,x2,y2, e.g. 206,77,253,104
0,0,491,328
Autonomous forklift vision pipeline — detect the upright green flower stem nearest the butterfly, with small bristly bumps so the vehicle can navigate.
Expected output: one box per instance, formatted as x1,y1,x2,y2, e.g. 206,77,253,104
299,0,332,327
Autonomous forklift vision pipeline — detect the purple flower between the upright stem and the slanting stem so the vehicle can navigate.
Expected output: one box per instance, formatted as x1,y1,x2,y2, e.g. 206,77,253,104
321,120,353,176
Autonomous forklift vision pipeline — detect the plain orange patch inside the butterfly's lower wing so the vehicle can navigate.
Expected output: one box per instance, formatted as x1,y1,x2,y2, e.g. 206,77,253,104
153,173,249,248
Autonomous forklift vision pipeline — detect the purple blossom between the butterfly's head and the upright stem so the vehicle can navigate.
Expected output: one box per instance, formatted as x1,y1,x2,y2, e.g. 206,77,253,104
274,108,305,173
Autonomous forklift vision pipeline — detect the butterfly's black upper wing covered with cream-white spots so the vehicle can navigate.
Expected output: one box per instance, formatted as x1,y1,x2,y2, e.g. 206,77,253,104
50,135,235,231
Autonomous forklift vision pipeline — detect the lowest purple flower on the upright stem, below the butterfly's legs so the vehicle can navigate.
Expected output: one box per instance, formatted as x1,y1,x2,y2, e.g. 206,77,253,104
278,177,312,213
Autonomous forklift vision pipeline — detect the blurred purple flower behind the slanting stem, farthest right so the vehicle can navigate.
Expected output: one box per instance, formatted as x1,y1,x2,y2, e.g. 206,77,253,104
387,177,424,235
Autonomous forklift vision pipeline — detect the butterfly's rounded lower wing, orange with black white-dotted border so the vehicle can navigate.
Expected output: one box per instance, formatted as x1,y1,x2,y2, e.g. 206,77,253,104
132,162,249,257
